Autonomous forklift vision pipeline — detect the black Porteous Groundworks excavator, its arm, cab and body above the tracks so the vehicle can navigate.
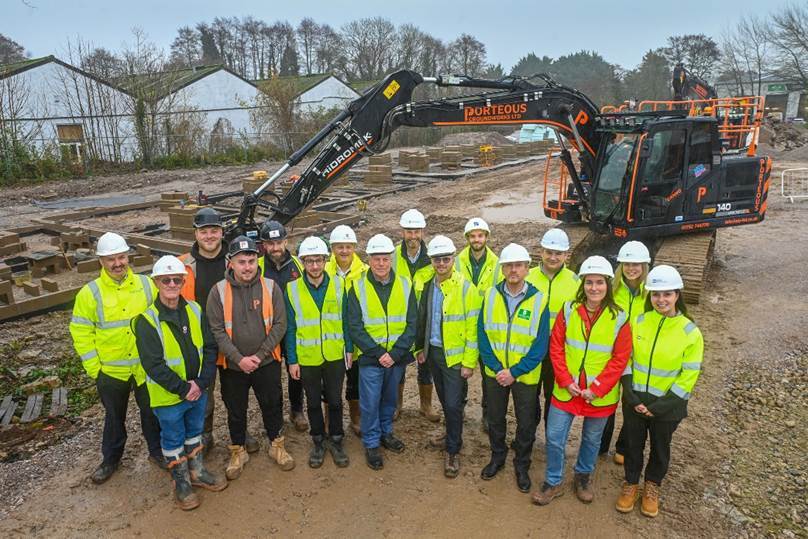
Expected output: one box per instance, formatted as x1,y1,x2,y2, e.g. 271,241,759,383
228,70,771,246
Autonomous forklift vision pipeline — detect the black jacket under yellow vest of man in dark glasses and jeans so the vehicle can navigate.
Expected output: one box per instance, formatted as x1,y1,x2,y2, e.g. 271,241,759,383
135,296,216,399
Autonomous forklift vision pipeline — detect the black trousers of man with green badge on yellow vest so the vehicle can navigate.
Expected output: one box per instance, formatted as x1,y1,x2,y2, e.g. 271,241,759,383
484,375,539,471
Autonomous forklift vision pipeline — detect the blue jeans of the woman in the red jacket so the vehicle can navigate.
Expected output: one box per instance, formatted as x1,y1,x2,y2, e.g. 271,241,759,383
544,404,609,486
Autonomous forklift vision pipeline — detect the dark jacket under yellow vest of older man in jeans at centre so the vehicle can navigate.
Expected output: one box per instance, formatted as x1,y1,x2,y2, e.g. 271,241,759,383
348,270,418,367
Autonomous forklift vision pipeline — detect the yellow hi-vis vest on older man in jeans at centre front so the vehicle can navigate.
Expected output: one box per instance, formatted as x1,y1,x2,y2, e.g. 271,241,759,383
353,272,412,352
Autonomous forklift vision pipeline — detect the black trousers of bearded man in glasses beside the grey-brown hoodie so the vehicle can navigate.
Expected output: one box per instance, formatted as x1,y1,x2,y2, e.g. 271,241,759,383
300,360,345,436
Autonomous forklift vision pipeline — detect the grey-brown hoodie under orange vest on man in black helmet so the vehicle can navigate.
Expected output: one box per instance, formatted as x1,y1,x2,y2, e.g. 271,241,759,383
206,271,286,370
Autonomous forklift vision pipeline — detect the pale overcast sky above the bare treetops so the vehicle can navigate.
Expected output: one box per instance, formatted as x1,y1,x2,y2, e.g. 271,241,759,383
0,0,785,71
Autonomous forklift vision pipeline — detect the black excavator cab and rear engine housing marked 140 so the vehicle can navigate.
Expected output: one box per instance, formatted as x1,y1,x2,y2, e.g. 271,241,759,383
589,113,771,238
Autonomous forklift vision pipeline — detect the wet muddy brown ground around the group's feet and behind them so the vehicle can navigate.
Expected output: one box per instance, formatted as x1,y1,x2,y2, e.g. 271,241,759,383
0,153,808,537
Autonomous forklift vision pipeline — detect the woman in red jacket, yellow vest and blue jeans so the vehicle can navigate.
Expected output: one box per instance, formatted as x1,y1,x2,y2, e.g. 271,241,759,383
533,256,631,505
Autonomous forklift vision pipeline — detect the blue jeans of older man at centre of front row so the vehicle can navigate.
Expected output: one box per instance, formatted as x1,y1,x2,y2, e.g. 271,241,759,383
359,364,405,448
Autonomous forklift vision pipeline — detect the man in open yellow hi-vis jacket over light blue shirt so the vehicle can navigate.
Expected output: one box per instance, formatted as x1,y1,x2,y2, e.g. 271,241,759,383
415,236,481,478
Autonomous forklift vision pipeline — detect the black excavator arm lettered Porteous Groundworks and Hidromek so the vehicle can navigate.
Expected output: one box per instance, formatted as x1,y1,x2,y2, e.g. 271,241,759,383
230,70,601,233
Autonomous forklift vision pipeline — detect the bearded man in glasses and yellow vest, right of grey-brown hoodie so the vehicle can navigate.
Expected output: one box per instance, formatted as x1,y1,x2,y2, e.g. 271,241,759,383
285,236,348,468
